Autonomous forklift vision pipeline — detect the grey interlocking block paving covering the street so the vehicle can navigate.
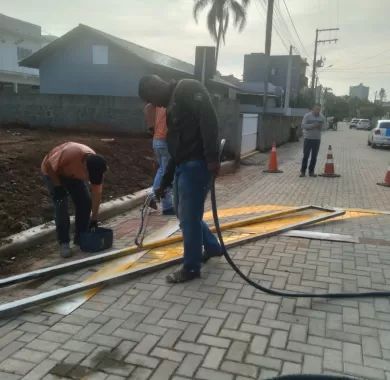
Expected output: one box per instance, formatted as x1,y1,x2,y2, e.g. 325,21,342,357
0,125,390,380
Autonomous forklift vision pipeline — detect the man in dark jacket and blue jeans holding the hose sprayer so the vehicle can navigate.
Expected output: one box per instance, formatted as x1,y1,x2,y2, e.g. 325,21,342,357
139,75,222,283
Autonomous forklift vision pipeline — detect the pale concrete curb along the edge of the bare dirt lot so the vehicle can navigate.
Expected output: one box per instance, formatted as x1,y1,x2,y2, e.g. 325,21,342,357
0,161,239,257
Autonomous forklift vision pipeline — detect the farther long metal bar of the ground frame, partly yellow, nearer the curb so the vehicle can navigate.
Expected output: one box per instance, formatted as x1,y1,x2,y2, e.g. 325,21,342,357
0,206,312,288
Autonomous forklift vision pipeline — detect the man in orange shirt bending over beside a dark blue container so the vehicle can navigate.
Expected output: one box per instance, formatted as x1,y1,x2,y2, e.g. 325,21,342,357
41,142,107,257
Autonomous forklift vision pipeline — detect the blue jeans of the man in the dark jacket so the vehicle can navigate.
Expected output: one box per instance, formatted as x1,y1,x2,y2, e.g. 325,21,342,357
174,160,222,272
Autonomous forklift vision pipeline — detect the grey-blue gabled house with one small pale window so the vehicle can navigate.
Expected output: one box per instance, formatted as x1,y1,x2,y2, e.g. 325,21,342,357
21,24,194,96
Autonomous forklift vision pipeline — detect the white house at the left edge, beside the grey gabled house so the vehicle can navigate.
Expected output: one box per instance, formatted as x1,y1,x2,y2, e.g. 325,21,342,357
0,14,53,93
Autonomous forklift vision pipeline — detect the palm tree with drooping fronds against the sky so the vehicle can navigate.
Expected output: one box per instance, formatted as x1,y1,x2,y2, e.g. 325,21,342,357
193,0,250,66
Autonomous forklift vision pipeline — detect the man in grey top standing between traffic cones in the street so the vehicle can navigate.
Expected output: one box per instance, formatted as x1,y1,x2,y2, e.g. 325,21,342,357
300,104,326,177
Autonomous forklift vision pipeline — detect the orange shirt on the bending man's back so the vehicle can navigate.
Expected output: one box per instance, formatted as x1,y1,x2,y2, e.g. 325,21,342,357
41,142,102,189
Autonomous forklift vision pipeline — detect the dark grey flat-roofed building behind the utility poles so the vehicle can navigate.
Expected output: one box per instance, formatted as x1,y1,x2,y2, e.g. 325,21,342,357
244,53,308,102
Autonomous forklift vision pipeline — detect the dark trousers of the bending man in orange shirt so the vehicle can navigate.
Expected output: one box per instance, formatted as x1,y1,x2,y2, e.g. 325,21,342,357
43,176,92,243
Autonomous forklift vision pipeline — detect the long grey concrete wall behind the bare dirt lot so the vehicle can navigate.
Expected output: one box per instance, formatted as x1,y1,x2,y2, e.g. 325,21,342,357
0,94,145,133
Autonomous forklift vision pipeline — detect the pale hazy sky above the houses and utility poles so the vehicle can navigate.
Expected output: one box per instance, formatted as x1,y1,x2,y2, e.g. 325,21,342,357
0,0,390,99
